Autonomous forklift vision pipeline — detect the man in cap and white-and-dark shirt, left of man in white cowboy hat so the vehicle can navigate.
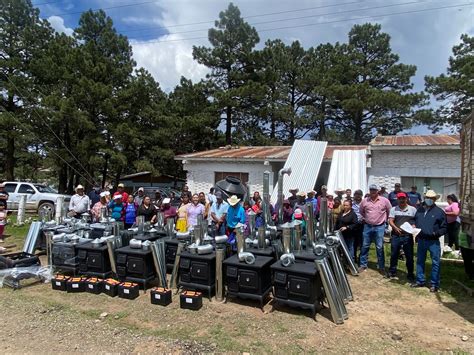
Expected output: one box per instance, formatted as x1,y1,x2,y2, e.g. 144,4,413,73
387,192,416,283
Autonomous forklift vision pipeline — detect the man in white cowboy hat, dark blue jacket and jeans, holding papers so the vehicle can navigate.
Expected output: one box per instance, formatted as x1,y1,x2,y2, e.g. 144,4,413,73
413,190,447,292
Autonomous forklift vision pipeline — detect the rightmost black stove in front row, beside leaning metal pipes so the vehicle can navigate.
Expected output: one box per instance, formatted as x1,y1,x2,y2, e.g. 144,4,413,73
271,260,323,317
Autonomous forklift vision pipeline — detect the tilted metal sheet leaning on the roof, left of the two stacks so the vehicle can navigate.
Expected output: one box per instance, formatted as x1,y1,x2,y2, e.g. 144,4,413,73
271,140,327,203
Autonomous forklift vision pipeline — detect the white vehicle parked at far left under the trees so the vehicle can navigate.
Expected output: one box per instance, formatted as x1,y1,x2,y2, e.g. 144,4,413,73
4,181,71,214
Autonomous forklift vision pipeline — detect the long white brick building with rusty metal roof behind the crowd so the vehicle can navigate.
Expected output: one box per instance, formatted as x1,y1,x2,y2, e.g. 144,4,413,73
175,135,461,199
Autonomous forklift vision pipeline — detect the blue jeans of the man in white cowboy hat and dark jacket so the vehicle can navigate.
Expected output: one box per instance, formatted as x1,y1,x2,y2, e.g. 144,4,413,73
416,239,441,288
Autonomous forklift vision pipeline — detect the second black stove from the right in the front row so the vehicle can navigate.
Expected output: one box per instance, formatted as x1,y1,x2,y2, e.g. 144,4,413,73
224,250,274,308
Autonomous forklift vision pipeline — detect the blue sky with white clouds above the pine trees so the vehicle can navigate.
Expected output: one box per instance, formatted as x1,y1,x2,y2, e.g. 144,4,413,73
33,0,474,133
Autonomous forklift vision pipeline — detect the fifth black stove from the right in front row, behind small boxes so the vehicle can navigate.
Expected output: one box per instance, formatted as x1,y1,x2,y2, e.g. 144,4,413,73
76,242,112,279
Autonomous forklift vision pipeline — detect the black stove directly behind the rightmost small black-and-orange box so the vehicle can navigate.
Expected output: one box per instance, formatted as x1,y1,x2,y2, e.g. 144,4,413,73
179,251,216,298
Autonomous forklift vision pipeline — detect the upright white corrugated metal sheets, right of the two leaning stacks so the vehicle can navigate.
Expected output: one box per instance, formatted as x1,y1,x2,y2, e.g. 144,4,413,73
327,149,367,193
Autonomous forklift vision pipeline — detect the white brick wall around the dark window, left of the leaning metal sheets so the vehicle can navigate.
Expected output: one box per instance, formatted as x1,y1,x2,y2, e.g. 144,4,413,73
183,161,274,193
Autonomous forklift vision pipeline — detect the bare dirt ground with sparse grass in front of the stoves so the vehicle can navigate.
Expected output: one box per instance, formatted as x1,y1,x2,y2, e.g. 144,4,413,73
0,264,474,353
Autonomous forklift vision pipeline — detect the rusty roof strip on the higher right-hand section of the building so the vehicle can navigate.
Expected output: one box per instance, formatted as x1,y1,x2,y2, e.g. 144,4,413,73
370,134,460,146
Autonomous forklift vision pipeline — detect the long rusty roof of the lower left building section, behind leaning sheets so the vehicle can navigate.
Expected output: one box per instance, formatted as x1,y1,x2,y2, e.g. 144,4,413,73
176,145,367,162
